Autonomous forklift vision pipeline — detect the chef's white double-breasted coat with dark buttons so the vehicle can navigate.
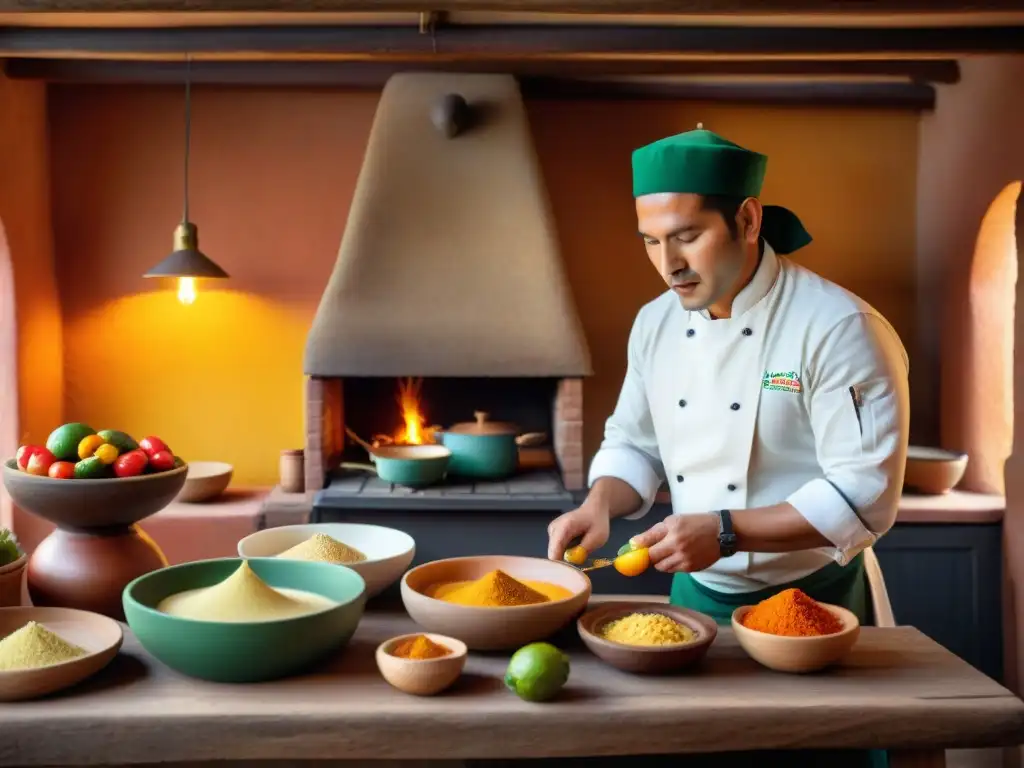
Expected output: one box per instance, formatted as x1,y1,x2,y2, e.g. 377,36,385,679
589,244,909,593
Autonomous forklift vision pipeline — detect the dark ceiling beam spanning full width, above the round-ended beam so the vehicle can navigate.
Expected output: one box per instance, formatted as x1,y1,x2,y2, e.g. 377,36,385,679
0,25,1024,60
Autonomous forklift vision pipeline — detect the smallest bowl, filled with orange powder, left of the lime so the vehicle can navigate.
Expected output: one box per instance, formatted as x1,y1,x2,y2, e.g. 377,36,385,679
377,633,469,696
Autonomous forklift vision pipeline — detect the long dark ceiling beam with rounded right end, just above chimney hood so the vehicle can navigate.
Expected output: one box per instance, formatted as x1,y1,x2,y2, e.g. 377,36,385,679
0,58,959,88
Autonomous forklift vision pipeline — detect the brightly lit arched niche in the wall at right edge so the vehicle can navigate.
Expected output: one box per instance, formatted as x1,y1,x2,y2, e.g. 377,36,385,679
942,181,1022,496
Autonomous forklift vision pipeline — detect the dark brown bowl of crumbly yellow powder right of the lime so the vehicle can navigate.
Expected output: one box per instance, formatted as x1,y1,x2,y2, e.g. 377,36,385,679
577,600,718,674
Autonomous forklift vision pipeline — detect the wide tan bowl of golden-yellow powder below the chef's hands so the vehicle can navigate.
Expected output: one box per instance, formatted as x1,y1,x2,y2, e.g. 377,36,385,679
401,555,591,650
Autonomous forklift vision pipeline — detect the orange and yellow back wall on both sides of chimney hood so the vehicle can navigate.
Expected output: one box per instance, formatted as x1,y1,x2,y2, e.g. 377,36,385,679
49,87,918,484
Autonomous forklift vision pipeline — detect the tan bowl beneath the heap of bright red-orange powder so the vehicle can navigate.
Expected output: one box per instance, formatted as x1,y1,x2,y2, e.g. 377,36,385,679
732,603,860,672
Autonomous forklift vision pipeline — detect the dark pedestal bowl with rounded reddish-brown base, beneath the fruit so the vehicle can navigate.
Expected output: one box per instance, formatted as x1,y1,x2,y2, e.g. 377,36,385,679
3,459,188,621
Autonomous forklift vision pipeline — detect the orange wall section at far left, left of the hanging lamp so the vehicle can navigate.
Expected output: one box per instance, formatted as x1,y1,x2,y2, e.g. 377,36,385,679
0,76,63,546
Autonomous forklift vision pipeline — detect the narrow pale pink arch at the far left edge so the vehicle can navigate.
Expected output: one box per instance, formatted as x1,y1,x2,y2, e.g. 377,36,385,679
0,221,18,527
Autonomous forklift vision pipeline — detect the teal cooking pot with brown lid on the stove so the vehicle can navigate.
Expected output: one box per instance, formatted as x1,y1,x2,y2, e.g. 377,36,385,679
434,411,547,480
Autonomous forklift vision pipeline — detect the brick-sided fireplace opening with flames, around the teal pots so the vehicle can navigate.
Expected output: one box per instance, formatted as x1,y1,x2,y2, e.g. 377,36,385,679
305,377,584,510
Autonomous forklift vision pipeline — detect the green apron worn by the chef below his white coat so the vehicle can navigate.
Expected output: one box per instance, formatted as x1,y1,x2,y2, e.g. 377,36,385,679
669,554,889,768
